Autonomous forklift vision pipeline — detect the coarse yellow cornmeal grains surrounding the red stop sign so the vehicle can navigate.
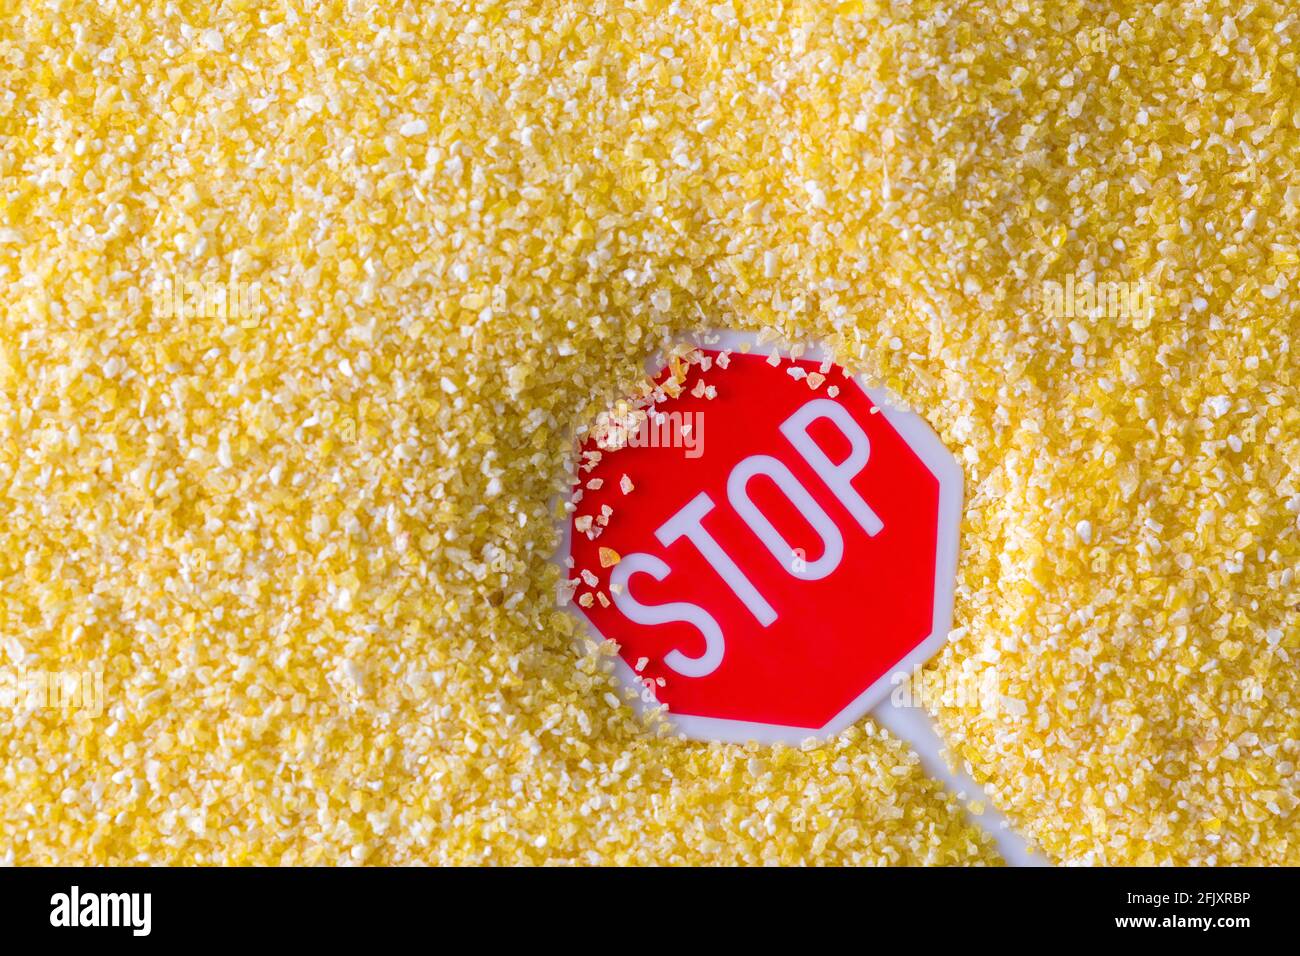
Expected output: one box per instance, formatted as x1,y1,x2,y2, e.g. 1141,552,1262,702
0,0,1300,864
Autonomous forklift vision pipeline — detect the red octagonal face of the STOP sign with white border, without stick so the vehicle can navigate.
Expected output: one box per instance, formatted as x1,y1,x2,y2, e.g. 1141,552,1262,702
564,339,962,743
